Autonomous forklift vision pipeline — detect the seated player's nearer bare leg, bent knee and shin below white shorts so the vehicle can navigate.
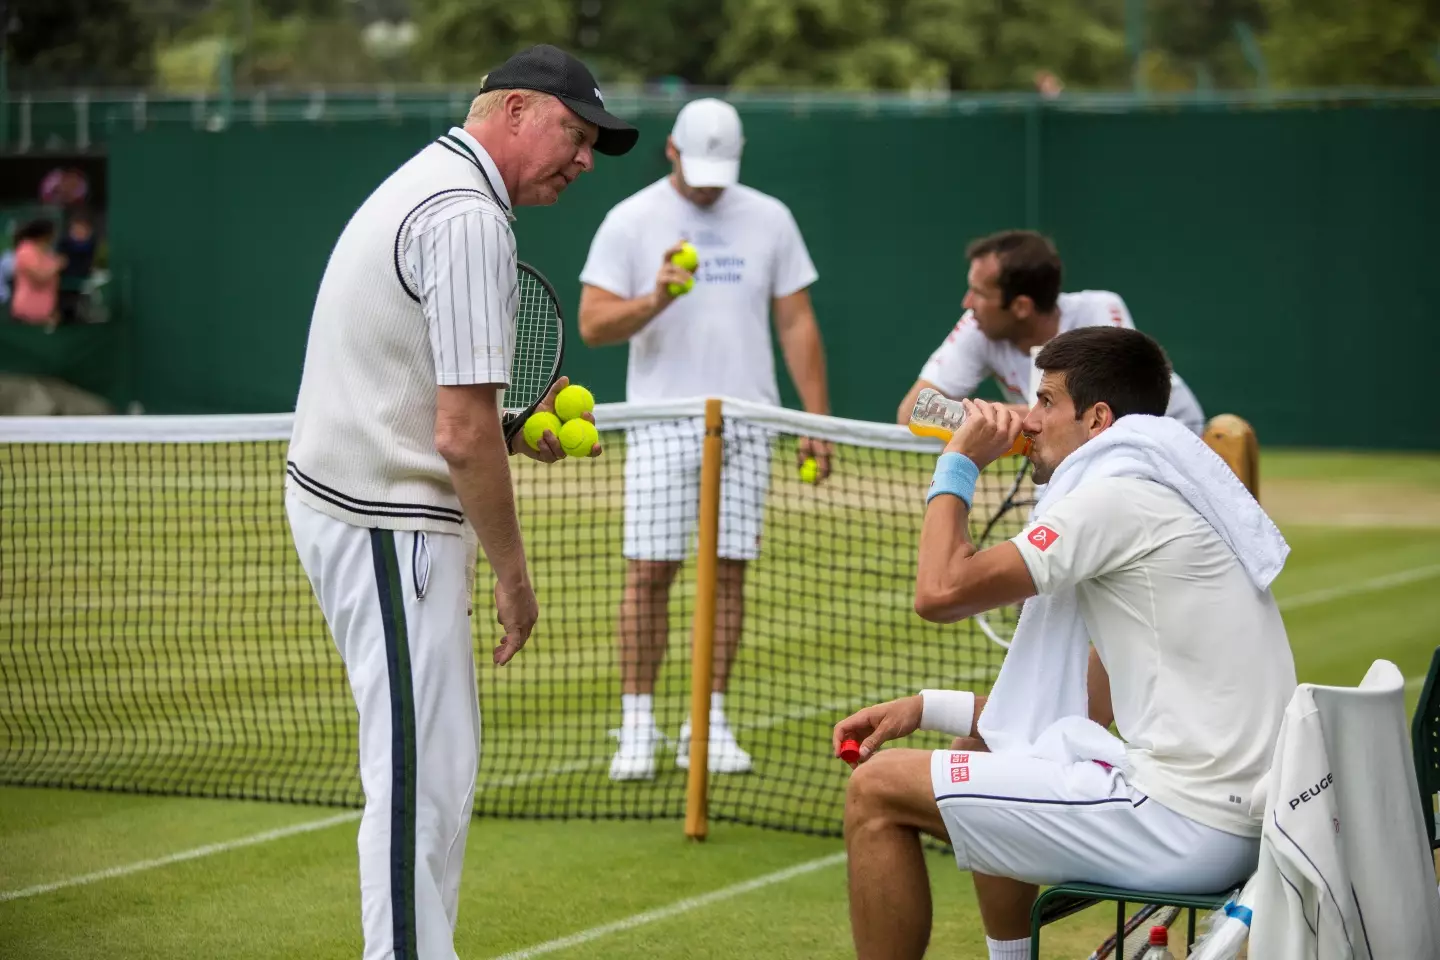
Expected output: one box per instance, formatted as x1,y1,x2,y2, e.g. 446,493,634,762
845,750,946,960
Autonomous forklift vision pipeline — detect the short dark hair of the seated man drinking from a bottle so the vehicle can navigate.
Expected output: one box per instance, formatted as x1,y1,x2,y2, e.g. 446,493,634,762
1035,327,1171,420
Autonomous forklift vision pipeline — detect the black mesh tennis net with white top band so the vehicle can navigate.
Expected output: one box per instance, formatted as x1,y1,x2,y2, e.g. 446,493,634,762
0,400,1028,833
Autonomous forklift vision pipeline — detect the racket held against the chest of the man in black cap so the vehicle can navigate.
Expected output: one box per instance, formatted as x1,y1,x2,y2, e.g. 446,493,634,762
501,262,564,448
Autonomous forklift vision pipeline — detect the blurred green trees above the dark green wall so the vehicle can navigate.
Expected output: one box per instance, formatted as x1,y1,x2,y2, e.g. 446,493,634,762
0,0,1440,91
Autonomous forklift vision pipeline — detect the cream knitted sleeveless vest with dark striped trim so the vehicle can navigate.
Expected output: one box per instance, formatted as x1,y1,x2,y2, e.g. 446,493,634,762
285,144,501,540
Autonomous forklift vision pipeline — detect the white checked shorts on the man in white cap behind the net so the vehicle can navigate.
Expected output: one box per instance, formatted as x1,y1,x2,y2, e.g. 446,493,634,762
624,417,772,560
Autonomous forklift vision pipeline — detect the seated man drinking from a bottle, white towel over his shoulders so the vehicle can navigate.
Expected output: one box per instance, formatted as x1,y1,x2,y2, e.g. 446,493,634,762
834,327,1295,960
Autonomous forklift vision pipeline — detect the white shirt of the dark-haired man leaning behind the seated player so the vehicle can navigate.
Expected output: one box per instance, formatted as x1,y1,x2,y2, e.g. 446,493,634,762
920,289,1205,433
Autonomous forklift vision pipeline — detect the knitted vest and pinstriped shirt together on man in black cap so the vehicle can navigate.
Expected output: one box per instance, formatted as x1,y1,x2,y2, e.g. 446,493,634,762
285,127,518,533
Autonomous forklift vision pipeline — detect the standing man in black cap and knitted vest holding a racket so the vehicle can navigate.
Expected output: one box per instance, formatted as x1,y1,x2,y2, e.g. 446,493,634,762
285,46,638,960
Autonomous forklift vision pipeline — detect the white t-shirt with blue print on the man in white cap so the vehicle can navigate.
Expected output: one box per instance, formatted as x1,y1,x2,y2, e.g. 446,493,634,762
580,178,819,404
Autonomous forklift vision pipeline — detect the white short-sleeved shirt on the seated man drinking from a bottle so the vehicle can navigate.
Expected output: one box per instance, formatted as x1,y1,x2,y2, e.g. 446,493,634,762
1012,478,1295,836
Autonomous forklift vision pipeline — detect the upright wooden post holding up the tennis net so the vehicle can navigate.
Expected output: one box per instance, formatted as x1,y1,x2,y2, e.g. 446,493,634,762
685,399,724,841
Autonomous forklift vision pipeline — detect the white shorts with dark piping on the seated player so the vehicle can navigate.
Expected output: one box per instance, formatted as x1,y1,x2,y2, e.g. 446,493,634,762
930,750,1260,892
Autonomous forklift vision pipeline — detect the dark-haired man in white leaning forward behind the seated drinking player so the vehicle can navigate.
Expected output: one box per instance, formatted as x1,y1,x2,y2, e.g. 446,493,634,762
896,230,1205,435
